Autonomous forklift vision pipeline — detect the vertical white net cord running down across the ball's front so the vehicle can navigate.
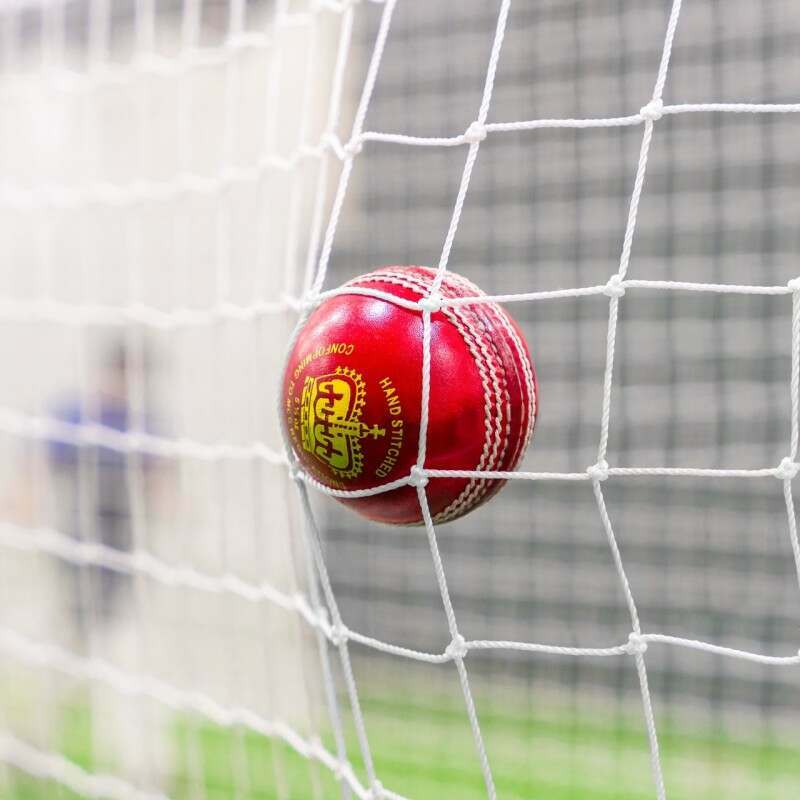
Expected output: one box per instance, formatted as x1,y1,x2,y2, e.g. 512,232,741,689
416,0,511,800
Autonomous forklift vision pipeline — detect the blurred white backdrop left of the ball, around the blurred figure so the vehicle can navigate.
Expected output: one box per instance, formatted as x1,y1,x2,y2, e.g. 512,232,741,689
0,0,342,793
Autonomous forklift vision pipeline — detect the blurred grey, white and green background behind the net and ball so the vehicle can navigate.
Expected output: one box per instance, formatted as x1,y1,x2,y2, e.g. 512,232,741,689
0,0,800,800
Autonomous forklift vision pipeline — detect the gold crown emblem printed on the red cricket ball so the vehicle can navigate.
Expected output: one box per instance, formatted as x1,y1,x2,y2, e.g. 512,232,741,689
300,367,386,478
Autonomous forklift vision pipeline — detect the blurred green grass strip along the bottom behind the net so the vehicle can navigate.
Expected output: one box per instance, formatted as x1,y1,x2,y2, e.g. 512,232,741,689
0,693,800,800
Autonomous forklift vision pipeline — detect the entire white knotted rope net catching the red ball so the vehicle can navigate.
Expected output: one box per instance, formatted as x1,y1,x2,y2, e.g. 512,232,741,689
0,0,800,800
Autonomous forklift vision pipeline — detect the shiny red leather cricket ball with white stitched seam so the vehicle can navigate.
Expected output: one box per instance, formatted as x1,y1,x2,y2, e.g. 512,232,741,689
282,267,537,525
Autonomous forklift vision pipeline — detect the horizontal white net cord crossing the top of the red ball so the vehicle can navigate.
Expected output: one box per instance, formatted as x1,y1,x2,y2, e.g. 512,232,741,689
0,280,797,331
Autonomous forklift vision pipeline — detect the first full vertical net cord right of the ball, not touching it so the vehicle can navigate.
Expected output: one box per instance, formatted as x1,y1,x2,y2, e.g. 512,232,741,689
592,0,682,800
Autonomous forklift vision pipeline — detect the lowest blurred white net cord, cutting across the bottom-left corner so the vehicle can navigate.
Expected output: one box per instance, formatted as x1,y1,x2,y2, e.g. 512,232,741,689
0,732,169,800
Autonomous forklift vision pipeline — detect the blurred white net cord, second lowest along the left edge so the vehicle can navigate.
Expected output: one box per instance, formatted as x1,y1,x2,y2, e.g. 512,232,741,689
0,627,380,800
